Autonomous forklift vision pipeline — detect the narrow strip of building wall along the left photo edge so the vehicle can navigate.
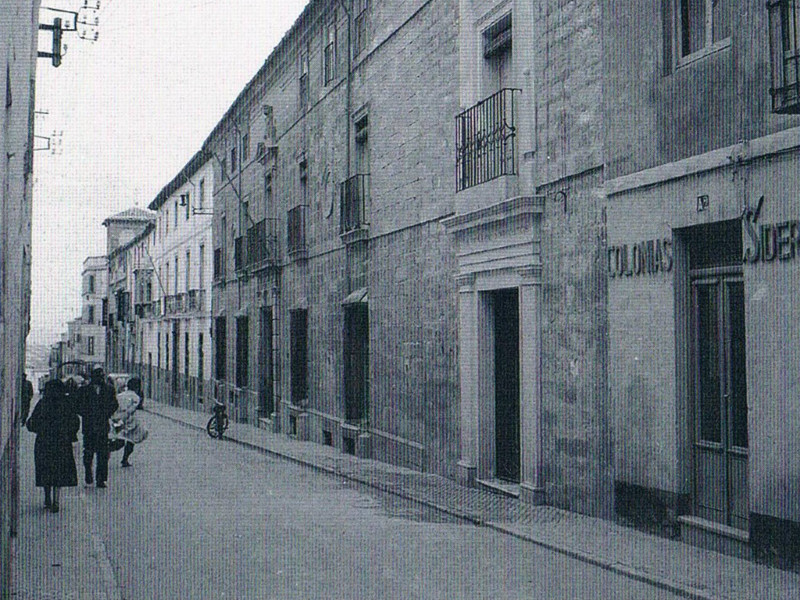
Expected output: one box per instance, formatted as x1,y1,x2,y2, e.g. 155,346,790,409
0,0,39,598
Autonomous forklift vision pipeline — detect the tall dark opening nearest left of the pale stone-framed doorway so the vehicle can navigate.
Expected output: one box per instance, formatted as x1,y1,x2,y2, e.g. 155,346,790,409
344,302,369,422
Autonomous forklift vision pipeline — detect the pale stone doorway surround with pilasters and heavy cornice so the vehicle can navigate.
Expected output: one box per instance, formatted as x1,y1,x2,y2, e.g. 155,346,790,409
443,196,544,503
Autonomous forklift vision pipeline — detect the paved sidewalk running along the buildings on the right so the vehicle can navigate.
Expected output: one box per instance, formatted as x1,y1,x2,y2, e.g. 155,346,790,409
145,400,800,600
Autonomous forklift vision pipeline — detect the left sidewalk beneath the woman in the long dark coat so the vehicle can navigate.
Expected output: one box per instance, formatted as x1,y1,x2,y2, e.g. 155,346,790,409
11,430,120,600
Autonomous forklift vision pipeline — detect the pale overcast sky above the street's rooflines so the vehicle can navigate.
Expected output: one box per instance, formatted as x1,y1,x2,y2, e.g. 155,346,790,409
28,0,307,345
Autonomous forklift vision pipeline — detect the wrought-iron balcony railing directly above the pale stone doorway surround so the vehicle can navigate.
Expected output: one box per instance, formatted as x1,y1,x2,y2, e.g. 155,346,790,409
456,88,520,192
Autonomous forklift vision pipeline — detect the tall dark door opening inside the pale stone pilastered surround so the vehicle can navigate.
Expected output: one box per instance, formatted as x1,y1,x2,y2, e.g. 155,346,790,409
492,289,520,482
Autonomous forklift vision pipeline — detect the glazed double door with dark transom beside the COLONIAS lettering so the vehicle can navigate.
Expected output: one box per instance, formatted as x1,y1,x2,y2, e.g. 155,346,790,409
686,220,749,529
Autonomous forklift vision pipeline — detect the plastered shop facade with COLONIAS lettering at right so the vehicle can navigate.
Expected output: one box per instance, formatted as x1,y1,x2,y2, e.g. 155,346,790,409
603,0,800,564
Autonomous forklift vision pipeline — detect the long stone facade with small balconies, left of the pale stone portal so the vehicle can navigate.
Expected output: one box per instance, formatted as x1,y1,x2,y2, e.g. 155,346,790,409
205,0,459,476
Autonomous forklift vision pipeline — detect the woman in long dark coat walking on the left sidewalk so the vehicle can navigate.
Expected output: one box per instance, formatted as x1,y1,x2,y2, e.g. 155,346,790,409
26,379,80,512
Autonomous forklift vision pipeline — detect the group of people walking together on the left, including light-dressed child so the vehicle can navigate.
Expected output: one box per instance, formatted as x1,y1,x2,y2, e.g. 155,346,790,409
23,367,147,512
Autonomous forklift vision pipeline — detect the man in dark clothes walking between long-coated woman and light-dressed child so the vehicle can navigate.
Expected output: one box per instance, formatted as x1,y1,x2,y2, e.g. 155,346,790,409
79,367,119,488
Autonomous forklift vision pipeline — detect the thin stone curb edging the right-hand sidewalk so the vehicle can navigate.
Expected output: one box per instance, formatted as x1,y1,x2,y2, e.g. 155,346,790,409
143,408,719,600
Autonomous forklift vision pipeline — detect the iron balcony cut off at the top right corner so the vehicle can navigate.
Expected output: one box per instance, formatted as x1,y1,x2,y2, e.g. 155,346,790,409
767,0,800,114
